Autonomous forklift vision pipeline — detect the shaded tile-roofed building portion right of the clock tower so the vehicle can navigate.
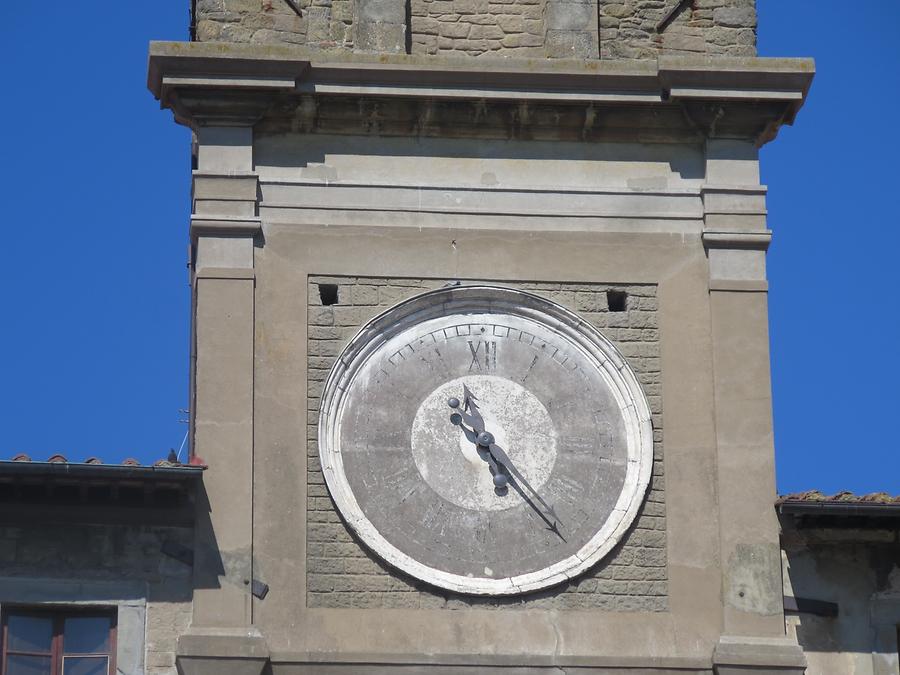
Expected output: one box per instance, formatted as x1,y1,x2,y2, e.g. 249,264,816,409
777,491,900,675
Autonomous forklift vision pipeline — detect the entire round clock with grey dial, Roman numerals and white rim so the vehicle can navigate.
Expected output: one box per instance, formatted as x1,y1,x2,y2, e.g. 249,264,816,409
319,286,653,595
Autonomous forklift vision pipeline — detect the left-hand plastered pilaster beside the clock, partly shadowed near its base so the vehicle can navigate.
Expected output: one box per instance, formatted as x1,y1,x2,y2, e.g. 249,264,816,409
178,125,268,675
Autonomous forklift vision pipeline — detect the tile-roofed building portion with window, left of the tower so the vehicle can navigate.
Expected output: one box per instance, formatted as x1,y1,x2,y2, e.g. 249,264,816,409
0,454,203,675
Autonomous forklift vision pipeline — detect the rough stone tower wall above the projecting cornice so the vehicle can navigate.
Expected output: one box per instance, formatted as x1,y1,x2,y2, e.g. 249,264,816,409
193,0,756,59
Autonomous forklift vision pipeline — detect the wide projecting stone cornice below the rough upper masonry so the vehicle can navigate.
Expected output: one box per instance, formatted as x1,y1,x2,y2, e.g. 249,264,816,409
148,42,815,144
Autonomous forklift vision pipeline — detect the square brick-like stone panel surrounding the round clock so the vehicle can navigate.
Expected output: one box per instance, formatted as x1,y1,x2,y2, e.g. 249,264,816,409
307,277,668,612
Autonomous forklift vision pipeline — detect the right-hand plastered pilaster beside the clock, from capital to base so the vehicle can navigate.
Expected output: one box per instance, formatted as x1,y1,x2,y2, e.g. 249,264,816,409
703,140,805,674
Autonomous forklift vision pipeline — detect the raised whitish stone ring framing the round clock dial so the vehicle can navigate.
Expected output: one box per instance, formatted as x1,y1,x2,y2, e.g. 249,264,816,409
318,286,653,596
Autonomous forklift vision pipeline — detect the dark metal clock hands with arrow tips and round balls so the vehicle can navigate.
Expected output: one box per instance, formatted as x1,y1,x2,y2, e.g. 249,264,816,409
447,385,565,541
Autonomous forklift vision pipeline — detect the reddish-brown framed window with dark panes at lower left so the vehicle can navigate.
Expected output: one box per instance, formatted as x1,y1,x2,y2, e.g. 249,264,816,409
0,608,116,675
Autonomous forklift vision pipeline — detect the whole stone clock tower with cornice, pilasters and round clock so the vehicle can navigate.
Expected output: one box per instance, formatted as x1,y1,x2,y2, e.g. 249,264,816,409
149,0,813,675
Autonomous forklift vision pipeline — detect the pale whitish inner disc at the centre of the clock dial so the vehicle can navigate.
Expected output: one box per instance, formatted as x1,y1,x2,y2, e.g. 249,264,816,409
412,375,557,511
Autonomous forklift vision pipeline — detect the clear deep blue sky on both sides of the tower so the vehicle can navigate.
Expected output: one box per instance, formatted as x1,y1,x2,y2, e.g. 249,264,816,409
0,0,900,493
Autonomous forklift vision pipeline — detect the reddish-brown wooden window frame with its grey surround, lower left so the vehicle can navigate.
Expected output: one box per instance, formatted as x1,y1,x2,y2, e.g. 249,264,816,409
0,603,119,675
